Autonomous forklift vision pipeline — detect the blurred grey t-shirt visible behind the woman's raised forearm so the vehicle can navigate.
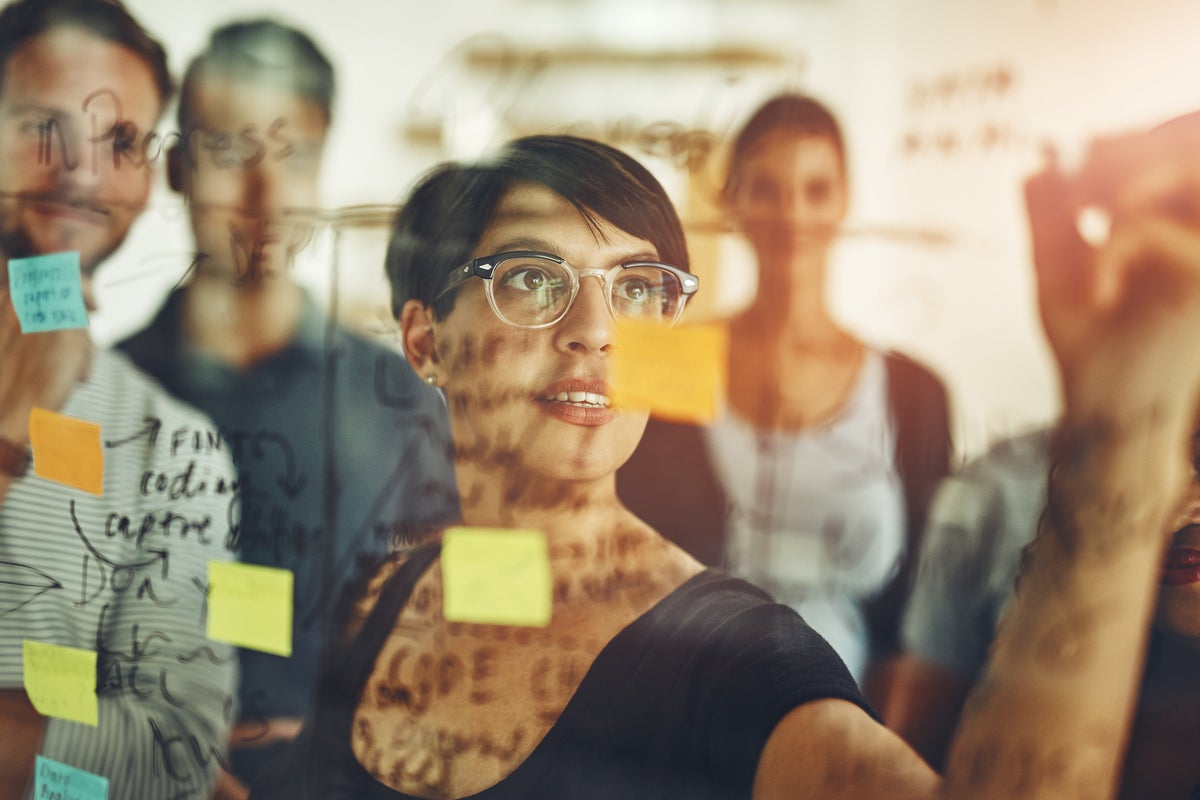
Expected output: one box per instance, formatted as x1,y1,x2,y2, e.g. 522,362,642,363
901,428,1051,681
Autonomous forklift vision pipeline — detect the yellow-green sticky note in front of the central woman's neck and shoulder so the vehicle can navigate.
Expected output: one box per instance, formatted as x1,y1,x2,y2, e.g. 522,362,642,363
442,528,551,627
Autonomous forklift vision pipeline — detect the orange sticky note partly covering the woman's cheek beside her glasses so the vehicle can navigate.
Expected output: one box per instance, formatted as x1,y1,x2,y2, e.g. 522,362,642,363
610,320,730,423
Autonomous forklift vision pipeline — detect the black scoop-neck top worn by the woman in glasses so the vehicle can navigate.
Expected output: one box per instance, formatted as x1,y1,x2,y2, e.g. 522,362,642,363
251,542,874,800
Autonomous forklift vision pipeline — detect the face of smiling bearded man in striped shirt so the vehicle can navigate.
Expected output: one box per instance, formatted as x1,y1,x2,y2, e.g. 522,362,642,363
0,28,161,273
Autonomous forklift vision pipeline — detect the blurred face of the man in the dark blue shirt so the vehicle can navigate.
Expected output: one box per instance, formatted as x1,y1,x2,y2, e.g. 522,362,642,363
176,76,329,285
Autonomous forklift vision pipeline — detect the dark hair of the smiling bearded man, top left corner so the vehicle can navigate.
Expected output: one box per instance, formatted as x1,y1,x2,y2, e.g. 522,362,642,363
0,0,173,106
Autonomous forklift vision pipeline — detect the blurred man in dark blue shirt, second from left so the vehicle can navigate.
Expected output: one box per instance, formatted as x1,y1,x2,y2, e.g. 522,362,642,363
118,19,457,796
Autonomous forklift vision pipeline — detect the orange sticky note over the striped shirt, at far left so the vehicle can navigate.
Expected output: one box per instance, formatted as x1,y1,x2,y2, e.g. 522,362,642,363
29,408,104,495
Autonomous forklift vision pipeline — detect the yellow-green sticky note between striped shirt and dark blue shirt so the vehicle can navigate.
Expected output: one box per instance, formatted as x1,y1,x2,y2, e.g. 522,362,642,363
208,561,293,656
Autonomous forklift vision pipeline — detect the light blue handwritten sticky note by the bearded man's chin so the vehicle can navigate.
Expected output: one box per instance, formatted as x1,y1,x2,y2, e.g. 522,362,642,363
8,251,88,333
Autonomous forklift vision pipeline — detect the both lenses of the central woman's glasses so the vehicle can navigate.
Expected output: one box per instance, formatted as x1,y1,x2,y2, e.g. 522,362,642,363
492,251,683,325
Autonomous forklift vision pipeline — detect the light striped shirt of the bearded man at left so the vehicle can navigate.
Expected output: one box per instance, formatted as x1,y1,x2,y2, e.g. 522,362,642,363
0,349,239,800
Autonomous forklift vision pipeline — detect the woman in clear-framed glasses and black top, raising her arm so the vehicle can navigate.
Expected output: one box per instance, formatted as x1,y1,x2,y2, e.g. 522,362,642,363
251,124,1200,800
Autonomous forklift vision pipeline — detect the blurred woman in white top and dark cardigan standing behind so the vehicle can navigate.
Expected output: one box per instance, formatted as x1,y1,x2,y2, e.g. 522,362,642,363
618,95,952,700
